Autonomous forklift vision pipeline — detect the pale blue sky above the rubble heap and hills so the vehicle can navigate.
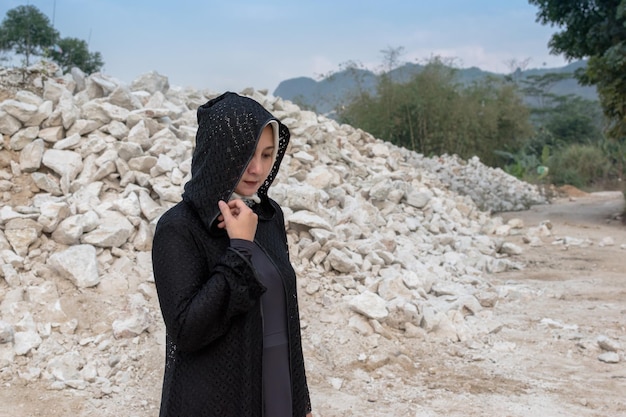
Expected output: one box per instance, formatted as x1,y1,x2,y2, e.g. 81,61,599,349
0,0,567,92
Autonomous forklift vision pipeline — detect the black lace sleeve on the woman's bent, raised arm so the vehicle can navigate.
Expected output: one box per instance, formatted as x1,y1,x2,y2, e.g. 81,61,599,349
152,205,264,351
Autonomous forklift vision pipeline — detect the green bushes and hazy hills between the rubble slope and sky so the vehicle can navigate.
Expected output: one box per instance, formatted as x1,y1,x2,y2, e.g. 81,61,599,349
274,57,626,190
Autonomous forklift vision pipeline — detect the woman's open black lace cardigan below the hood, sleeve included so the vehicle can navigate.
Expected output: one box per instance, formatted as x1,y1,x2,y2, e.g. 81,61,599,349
152,196,311,417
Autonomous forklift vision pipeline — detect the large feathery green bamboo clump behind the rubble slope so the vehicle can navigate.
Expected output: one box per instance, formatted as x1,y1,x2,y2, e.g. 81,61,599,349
338,58,532,166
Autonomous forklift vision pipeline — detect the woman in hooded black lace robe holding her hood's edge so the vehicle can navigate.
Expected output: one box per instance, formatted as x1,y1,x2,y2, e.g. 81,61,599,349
152,92,311,417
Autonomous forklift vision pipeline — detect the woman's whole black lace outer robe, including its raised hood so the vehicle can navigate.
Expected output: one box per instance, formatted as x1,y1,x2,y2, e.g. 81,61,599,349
152,93,311,417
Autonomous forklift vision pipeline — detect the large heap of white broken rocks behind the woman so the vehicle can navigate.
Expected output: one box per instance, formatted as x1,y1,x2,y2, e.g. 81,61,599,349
0,62,617,415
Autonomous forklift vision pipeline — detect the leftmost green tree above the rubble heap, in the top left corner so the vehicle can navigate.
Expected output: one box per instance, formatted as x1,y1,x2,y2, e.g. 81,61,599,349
0,5,59,66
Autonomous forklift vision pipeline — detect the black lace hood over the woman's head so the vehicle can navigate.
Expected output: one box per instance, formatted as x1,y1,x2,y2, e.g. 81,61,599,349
183,92,290,229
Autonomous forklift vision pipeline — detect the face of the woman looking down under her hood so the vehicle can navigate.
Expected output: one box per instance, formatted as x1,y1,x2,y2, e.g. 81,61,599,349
235,125,276,196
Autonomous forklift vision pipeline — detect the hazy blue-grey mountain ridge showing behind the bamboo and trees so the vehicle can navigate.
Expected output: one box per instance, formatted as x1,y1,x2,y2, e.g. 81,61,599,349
273,61,598,116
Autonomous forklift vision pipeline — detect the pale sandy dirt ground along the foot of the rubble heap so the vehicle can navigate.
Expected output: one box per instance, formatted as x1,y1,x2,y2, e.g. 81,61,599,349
0,192,626,417
